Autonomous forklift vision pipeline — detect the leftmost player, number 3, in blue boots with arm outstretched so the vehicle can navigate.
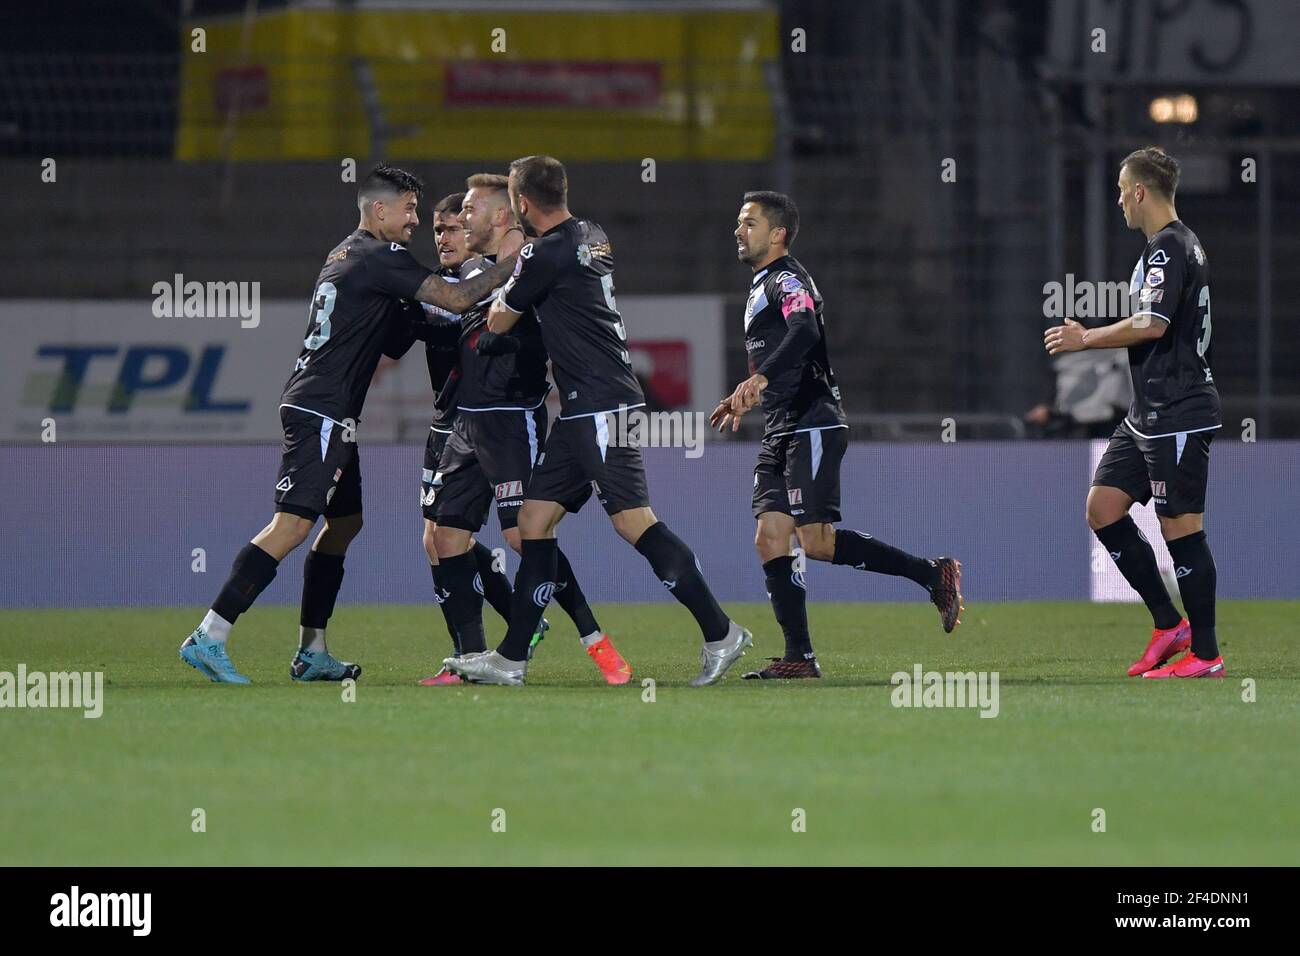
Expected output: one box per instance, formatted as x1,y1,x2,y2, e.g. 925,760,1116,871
181,164,517,684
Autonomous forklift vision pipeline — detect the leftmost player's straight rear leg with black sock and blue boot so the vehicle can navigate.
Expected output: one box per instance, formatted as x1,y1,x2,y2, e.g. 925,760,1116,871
289,514,361,682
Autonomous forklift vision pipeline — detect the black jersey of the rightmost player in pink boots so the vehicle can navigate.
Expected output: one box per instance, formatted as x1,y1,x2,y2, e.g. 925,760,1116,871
1127,219,1221,438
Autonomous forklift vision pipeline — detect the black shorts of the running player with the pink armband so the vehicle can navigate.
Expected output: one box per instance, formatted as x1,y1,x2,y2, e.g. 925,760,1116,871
754,428,849,527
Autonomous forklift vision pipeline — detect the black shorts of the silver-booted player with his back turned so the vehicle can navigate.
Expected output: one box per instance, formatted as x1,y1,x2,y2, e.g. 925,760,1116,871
527,412,650,515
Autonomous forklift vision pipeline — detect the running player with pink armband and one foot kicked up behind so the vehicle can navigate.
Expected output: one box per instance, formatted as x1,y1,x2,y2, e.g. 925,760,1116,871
710,190,963,680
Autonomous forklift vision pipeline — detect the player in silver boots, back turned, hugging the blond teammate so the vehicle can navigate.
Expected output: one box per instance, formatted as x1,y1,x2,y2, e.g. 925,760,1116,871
446,156,754,687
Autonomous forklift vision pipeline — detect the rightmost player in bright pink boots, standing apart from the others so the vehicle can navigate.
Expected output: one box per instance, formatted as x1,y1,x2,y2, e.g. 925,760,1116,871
1043,146,1225,678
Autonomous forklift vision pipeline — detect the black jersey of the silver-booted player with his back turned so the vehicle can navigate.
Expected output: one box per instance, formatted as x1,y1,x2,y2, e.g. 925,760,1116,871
502,217,645,418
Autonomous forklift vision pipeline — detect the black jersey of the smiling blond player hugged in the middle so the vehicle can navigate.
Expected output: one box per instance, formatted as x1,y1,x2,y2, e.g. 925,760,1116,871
456,256,551,411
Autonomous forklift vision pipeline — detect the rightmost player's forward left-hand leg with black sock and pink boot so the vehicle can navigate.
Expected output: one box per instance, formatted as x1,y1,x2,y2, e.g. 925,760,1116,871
1088,485,1192,678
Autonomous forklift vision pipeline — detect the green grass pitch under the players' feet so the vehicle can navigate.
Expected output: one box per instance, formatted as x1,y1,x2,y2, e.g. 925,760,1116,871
0,602,1300,865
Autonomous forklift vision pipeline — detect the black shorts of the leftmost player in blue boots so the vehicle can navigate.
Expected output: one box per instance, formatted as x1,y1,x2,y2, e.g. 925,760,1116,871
276,408,361,522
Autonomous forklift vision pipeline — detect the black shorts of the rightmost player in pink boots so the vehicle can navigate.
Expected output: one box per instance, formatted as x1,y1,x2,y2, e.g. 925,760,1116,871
1092,424,1214,518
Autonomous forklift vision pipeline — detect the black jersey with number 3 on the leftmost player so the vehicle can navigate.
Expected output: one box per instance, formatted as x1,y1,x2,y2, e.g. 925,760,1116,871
281,229,433,421
